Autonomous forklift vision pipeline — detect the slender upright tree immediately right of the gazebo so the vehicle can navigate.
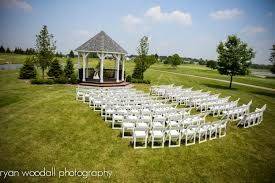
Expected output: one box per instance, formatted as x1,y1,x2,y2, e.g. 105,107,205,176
132,36,156,80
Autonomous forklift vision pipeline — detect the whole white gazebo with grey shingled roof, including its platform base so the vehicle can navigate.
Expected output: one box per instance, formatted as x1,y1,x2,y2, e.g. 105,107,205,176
75,31,128,86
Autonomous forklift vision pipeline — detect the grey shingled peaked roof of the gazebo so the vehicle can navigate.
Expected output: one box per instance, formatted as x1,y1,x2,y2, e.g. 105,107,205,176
75,31,127,54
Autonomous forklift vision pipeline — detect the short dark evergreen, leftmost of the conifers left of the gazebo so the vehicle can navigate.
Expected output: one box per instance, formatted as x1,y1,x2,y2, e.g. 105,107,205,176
19,56,36,79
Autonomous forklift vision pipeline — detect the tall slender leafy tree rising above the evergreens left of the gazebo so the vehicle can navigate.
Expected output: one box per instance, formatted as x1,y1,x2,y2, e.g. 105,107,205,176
36,25,56,79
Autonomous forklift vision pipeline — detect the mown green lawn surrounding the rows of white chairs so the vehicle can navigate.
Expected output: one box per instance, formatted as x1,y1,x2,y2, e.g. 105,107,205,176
0,61,275,182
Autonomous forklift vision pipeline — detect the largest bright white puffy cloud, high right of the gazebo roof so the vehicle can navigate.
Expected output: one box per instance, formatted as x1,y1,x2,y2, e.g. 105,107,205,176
145,6,192,25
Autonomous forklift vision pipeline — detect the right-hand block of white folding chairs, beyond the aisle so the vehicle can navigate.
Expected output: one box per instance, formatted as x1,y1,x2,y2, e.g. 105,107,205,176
150,85,266,128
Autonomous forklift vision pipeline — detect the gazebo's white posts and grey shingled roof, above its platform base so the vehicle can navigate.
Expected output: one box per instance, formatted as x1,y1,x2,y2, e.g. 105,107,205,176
75,31,127,83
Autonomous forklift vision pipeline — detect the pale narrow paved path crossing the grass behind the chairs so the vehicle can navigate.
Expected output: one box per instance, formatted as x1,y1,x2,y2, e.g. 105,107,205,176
150,69,275,92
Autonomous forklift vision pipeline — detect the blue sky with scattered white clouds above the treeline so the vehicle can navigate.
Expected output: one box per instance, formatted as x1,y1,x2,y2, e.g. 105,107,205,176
0,0,275,64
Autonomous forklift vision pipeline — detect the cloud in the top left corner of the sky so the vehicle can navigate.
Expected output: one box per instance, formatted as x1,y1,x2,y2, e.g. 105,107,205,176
0,0,32,12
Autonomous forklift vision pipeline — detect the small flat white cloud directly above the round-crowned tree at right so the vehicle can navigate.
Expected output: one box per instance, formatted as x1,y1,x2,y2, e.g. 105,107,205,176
209,8,243,20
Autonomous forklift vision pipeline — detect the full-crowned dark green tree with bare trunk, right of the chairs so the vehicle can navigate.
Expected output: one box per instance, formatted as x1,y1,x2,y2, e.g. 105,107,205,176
217,35,255,88
